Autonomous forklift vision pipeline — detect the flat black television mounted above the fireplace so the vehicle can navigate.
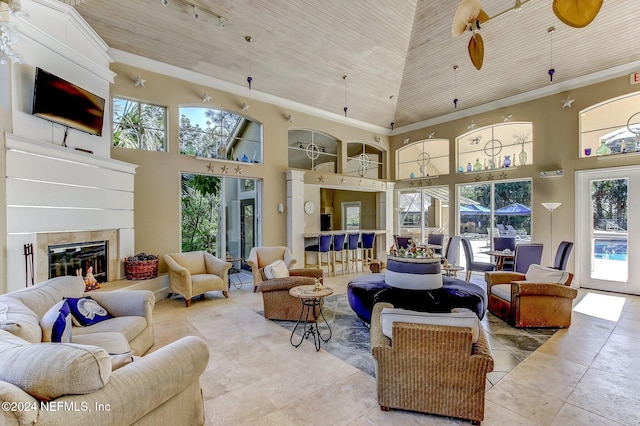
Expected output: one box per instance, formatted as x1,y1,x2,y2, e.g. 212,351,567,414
32,68,104,136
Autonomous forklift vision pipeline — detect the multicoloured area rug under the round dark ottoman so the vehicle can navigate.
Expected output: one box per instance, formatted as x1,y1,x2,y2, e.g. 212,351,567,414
260,294,556,377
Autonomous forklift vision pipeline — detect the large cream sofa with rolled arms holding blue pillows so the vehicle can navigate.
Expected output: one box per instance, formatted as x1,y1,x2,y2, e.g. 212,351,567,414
0,277,209,426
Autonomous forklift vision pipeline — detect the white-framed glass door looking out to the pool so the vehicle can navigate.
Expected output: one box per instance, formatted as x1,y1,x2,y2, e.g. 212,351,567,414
576,166,640,294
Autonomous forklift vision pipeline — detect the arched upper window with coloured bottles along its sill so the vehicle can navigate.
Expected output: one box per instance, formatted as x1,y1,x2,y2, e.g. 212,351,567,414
456,122,533,173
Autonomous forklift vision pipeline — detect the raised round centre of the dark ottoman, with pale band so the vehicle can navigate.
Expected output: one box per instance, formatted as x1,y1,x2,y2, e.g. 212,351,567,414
384,259,442,290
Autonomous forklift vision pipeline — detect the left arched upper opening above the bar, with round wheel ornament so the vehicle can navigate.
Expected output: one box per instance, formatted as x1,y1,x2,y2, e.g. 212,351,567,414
289,129,338,173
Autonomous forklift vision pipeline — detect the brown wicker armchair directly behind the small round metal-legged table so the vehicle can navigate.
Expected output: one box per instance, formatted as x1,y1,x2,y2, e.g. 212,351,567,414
258,268,324,321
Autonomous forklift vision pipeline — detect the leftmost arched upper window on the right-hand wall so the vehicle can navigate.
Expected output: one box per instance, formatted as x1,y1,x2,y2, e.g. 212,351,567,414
396,139,449,180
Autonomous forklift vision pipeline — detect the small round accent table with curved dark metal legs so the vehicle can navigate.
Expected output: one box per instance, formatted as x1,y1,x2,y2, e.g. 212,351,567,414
289,285,333,351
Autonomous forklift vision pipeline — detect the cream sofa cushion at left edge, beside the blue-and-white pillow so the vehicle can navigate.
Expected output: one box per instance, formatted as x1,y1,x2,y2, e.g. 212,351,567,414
0,297,42,343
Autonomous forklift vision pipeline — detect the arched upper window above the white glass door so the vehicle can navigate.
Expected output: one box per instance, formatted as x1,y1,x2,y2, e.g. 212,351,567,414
580,92,640,157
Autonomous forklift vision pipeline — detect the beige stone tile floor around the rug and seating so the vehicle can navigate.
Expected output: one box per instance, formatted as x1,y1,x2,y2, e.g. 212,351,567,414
152,276,640,426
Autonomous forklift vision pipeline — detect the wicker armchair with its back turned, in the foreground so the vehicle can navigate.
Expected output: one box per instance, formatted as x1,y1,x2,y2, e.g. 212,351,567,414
371,303,493,424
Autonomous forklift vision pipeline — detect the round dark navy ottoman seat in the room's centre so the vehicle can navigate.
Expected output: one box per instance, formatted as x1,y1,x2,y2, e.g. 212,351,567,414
347,274,487,323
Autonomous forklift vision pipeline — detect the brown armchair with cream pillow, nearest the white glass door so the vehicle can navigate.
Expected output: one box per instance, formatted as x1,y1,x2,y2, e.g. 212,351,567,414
485,264,578,328
